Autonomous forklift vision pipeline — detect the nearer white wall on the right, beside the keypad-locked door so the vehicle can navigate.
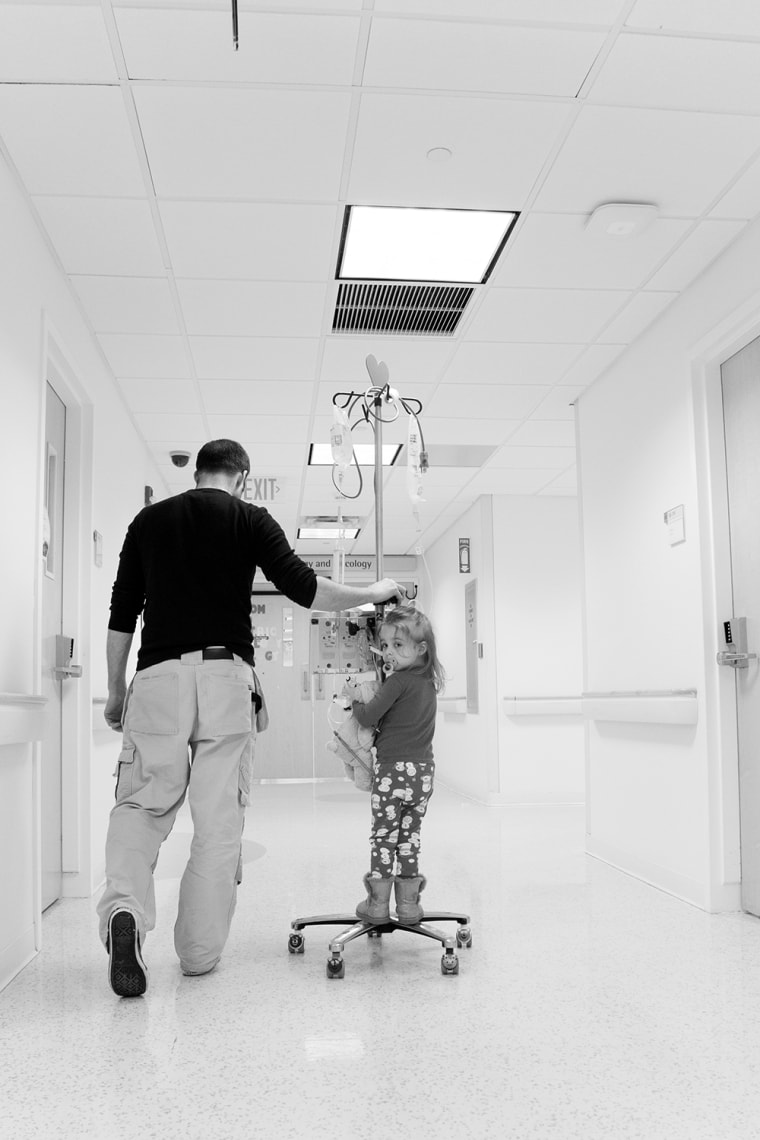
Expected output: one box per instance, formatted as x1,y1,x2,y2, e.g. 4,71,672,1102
579,214,760,909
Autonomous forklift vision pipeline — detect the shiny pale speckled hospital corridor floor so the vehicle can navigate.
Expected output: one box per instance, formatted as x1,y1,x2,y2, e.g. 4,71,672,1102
0,782,760,1140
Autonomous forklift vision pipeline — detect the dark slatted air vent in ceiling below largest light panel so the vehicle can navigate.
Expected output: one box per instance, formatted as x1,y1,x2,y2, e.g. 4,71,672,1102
333,282,475,336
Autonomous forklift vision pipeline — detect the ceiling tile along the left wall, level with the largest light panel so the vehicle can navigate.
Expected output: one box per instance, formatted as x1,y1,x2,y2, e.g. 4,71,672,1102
34,197,165,277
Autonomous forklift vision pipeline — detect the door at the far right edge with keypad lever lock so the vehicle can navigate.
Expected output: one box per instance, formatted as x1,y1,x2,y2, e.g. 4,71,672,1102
720,339,760,917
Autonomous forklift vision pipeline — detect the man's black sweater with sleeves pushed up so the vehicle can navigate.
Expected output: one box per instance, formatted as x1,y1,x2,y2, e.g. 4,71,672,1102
108,487,317,669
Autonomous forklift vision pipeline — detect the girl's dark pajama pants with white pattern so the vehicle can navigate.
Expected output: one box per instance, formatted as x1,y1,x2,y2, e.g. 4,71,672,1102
369,760,435,879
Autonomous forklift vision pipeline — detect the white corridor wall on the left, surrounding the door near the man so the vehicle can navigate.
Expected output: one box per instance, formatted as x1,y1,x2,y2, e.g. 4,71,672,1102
0,151,160,987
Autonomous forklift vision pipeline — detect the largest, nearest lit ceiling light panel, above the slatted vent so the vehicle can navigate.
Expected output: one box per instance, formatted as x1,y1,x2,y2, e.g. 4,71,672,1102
337,206,517,284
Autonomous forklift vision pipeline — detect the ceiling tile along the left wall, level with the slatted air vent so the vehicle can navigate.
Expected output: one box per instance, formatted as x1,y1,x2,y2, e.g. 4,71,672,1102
72,277,179,335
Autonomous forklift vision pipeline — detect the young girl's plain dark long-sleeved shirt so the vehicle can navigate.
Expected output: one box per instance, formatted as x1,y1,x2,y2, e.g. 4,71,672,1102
351,669,436,764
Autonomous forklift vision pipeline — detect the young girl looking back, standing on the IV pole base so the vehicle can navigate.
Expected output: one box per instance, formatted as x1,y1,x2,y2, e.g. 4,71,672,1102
352,605,444,926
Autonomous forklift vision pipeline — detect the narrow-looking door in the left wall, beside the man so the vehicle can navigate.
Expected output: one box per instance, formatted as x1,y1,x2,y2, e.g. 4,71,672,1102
41,384,65,910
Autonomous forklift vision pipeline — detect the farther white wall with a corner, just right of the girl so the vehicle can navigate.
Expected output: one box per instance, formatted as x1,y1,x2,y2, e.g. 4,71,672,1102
419,496,585,805
